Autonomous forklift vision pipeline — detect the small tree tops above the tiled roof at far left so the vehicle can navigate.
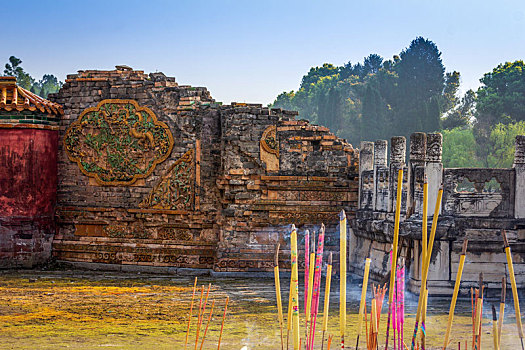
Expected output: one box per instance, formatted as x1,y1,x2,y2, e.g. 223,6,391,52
4,56,62,98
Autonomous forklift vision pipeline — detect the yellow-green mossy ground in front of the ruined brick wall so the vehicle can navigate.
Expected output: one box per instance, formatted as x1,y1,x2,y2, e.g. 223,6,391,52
0,271,519,350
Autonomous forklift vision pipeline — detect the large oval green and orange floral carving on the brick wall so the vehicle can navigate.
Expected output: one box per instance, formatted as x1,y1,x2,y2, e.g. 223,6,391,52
64,100,173,185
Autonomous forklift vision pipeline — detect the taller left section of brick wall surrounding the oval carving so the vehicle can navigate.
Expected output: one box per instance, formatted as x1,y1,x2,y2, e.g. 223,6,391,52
50,69,220,268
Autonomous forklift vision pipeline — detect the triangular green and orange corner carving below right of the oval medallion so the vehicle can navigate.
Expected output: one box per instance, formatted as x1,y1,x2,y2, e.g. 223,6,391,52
139,150,194,210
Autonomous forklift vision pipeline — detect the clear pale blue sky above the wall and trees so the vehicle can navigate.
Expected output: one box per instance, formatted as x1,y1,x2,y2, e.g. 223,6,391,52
0,0,525,104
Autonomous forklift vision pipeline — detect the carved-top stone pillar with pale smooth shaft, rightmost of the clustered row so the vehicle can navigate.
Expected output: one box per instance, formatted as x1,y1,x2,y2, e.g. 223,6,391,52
425,133,443,216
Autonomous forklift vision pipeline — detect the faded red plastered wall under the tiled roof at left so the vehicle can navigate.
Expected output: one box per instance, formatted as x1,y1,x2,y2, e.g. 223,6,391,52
0,128,58,267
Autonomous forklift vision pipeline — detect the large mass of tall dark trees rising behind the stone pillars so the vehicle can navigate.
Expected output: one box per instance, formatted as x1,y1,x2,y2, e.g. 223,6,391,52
273,37,460,144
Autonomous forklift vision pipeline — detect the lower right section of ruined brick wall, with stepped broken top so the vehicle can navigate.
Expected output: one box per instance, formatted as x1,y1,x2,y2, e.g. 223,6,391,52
217,105,358,271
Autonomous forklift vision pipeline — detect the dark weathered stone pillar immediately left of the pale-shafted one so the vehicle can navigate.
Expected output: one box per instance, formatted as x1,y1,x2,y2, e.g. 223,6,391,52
407,132,427,214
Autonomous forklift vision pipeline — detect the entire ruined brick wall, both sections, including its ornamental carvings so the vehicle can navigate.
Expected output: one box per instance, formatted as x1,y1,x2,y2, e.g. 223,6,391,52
53,67,358,271
